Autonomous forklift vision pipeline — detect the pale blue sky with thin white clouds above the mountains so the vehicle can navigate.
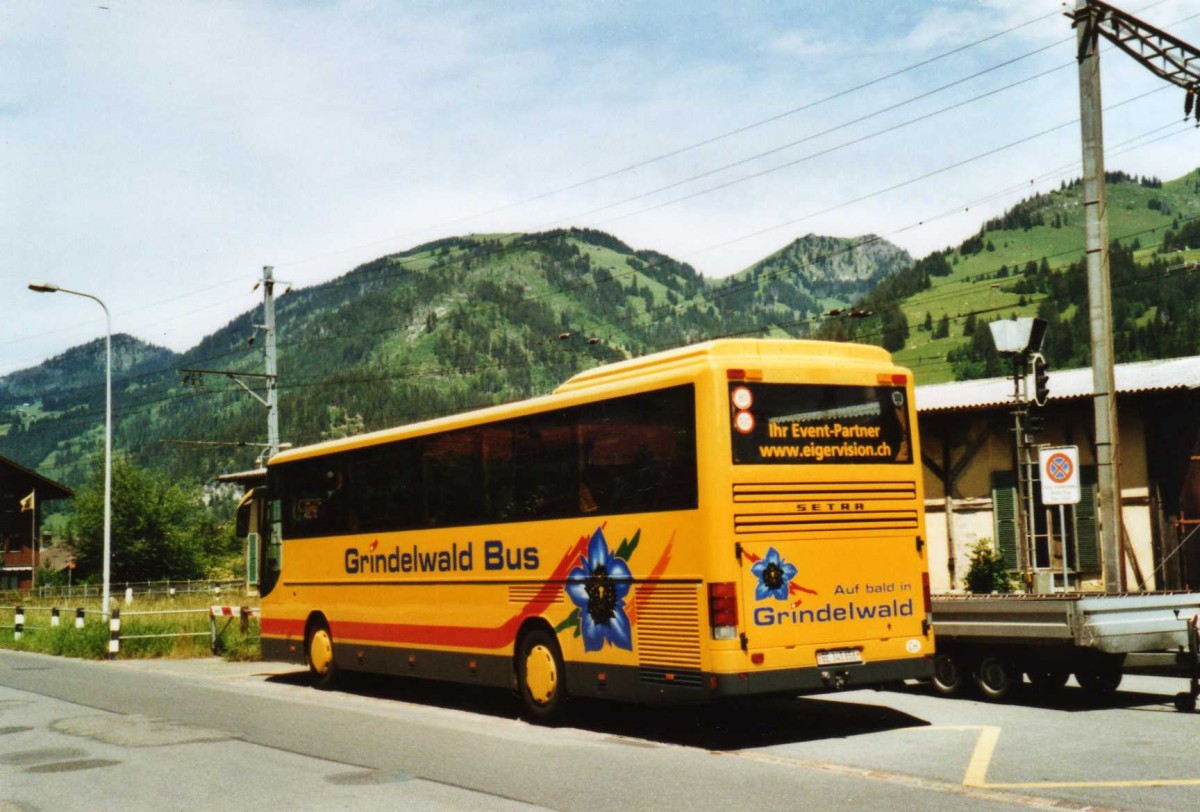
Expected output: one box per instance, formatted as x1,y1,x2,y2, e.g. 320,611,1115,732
0,0,1200,375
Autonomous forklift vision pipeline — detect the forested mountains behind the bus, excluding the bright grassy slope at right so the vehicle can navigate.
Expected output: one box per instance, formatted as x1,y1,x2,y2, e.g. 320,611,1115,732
0,229,912,483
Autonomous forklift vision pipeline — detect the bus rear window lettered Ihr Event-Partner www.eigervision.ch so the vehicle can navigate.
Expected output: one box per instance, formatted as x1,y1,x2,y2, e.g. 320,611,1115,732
730,383,912,465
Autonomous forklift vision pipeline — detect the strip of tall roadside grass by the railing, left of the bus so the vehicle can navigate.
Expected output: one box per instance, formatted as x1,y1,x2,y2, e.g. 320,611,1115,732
0,595,262,661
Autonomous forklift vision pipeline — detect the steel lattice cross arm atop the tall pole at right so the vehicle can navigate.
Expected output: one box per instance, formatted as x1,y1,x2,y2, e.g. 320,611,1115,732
1067,0,1200,125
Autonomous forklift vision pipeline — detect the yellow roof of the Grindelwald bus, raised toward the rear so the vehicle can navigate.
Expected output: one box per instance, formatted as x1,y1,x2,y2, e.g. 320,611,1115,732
269,338,892,465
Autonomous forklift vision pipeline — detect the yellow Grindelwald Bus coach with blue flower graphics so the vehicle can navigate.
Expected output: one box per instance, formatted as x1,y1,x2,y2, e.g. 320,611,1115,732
244,339,934,721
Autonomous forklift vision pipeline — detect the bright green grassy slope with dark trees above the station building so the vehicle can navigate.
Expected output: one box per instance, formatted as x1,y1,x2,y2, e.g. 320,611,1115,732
821,170,1200,383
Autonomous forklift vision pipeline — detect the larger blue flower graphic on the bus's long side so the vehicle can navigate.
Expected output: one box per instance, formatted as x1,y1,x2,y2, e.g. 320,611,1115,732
566,528,634,651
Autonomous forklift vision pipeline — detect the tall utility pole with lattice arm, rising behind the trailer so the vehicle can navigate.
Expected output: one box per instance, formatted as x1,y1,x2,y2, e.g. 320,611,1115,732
1067,0,1200,593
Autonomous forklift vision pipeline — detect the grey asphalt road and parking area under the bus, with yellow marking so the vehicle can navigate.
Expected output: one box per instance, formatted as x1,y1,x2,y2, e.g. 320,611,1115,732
0,651,1200,812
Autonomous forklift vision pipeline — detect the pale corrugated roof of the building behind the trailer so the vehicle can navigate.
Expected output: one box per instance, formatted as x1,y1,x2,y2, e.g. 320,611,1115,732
917,355,1200,413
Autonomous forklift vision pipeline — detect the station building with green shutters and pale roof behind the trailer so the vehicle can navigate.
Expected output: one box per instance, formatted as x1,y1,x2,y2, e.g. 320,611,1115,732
917,356,1200,593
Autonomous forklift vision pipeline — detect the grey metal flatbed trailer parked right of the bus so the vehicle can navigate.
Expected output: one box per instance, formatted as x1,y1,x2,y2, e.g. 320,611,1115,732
932,593,1200,710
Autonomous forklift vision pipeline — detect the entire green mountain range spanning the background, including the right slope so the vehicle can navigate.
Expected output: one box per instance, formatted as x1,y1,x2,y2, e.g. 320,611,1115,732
9,164,1200,485
